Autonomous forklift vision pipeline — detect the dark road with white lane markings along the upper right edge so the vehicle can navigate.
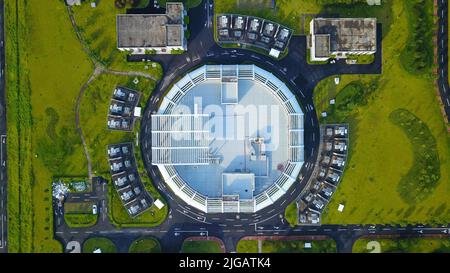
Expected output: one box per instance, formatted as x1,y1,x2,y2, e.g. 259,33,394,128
438,0,450,122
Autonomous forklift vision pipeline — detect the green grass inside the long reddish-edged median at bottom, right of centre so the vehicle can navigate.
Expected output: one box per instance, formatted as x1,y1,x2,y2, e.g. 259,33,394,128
237,239,336,253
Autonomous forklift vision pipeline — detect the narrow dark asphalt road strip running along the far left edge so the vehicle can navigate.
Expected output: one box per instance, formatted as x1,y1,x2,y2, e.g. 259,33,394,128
0,0,8,253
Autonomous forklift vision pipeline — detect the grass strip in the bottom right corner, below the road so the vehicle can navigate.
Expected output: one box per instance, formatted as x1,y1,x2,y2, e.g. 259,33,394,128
352,238,450,253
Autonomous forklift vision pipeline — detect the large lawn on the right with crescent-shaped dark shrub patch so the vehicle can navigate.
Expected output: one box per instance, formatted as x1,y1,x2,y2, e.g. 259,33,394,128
320,1,450,224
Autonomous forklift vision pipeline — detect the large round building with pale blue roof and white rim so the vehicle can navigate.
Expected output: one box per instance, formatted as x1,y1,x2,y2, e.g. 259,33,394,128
151,65,304,213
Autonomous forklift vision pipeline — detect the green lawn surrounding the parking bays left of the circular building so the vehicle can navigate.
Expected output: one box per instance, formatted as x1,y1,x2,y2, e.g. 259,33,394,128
80,71,168,226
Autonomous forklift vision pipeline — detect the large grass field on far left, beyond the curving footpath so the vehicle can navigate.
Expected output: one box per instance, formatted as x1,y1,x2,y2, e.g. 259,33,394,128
5,0,92,252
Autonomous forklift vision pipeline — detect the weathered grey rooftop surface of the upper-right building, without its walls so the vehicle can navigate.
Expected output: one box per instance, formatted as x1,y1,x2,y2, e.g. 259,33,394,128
314,18,377,53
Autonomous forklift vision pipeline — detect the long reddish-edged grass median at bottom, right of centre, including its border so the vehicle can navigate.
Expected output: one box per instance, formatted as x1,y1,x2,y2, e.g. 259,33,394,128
237,236,337,253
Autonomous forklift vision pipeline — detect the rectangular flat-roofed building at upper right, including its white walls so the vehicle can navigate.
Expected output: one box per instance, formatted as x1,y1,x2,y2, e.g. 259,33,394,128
310,18,377,61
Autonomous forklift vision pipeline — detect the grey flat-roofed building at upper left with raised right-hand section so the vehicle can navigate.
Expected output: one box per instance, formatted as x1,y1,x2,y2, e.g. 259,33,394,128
116,2,187,54
